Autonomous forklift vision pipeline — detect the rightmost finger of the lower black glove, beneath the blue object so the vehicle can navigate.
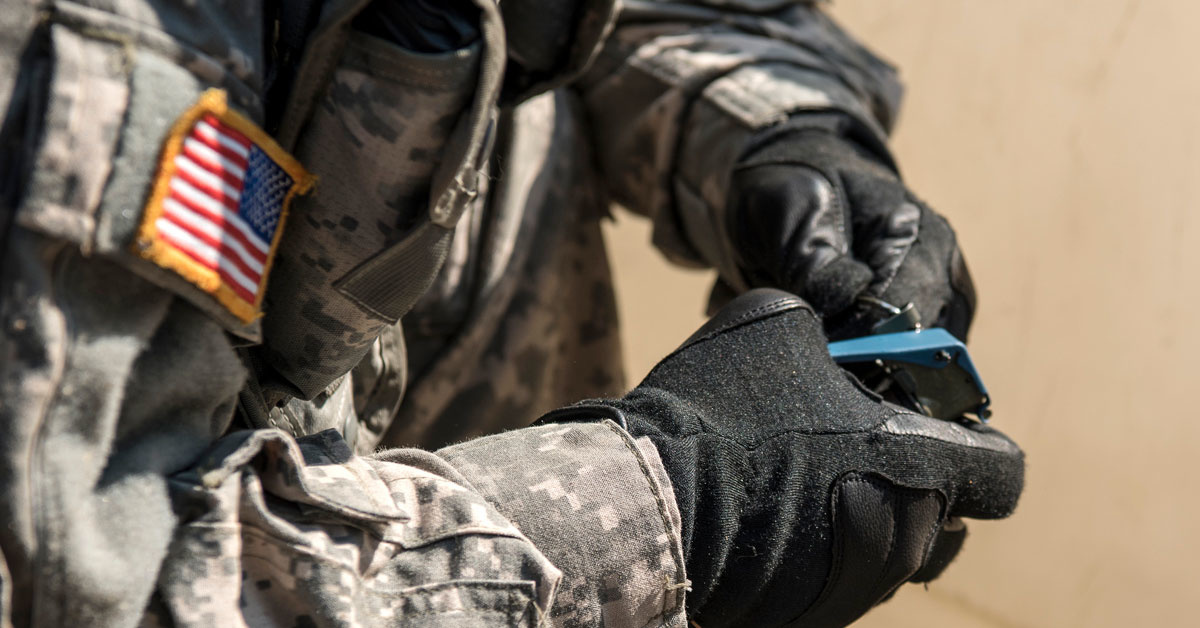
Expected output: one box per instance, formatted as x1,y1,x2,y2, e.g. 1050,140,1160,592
881,412,1025,519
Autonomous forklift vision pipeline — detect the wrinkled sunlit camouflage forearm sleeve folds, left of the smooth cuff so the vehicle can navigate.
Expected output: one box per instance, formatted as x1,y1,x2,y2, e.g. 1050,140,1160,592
146,430,560,627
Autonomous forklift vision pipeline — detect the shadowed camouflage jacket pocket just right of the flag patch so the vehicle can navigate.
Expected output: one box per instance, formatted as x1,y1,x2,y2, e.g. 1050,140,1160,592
263,34,481,399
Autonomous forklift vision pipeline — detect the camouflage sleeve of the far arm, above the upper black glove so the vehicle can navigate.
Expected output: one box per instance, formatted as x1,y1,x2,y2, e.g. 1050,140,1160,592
577,0,901,277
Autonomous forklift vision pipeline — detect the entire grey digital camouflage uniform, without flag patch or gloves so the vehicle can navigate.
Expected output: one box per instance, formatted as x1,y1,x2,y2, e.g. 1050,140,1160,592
0,0,898,626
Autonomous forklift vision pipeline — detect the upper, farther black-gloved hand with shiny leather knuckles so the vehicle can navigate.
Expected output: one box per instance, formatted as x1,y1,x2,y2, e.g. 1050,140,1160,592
725,119,976,340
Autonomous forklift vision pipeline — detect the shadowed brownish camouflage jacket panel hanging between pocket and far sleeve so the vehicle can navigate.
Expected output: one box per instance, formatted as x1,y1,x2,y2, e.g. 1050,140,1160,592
383,90,624,447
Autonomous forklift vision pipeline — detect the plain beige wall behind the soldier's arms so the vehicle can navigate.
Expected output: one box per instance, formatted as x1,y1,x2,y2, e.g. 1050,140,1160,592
611,0,1200,628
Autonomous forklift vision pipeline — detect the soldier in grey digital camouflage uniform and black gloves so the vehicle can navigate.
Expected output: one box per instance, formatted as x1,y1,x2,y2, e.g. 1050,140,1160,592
0,0,1022,627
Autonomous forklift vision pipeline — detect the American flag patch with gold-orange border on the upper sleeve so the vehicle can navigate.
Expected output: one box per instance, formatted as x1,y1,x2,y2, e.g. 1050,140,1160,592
134,90,313,323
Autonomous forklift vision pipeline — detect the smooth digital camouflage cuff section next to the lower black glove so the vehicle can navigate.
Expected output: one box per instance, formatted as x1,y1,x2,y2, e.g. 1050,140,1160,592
437,421,689,628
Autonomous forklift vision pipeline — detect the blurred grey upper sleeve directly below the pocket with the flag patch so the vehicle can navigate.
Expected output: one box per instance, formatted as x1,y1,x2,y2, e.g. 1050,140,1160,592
0,227,245,626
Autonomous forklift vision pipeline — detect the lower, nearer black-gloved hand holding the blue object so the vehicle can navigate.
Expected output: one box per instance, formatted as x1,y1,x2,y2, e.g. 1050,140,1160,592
542,289,1024,628
